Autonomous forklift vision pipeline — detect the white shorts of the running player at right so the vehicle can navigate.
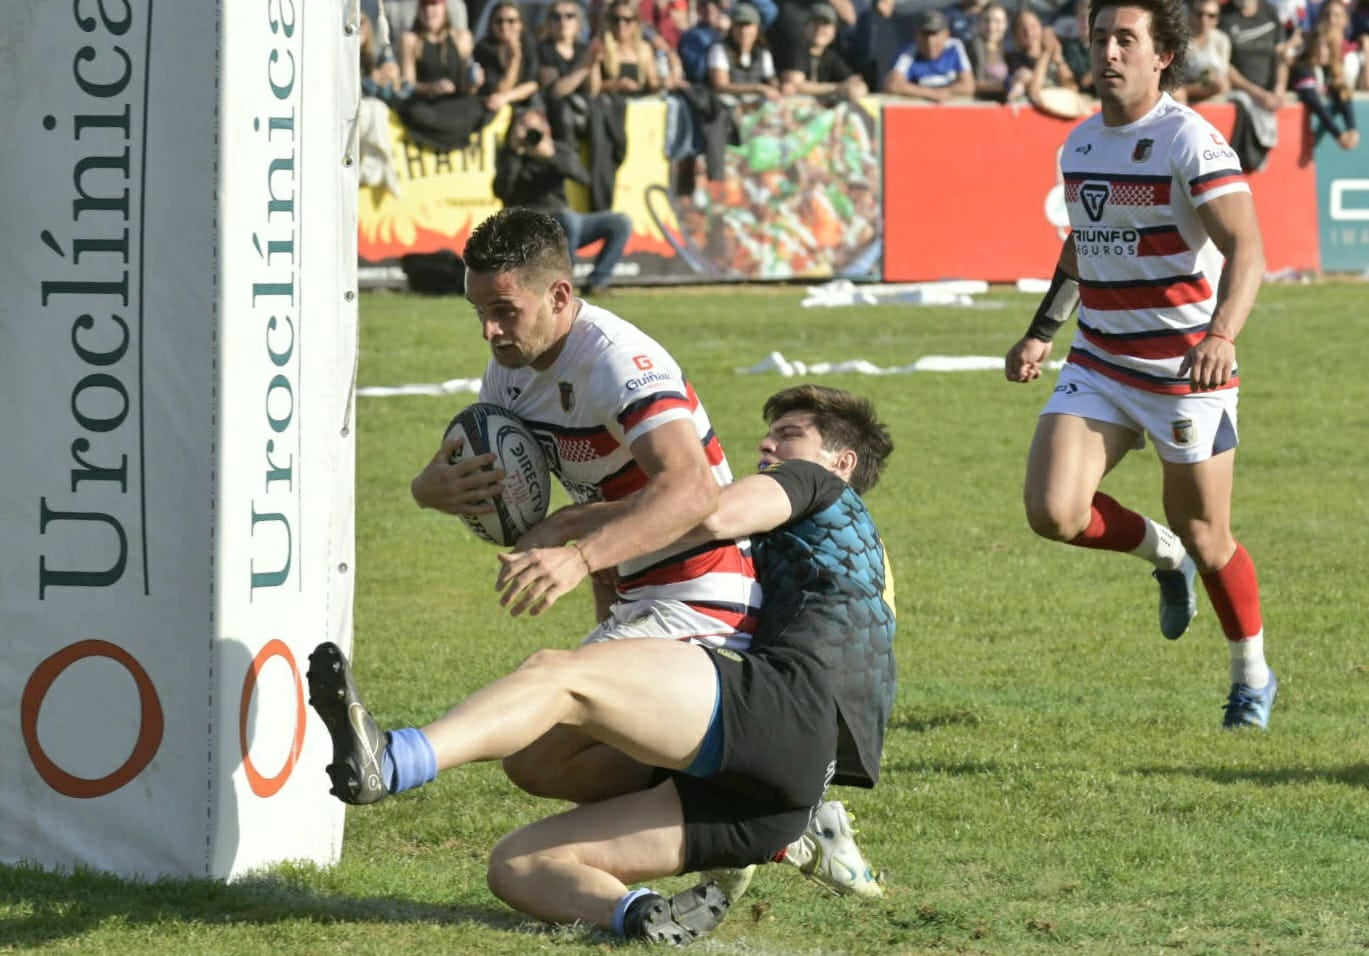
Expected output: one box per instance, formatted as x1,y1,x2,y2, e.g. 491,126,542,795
1040,363,1240,464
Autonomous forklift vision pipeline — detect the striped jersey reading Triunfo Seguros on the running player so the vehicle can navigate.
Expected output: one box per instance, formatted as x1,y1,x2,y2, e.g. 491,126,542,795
1060,93,1250,394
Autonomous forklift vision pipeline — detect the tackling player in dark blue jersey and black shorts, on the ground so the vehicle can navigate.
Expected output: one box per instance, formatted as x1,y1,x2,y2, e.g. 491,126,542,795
309,386,895,944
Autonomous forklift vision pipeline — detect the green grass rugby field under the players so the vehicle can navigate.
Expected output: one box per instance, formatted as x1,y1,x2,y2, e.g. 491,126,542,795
0,284,1369,956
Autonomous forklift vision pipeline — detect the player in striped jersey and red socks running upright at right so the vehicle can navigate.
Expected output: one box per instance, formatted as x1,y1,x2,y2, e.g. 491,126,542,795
1005,0,1279,729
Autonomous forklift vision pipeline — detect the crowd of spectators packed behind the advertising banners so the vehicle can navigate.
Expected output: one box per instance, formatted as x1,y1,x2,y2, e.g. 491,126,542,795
361,0,1369,198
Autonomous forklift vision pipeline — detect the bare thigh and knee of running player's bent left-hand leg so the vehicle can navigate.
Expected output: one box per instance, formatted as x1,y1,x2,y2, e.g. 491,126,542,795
1023,414,1139,541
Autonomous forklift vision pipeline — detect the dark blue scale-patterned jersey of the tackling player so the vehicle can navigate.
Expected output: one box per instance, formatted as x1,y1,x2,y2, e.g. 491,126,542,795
752,460,898,788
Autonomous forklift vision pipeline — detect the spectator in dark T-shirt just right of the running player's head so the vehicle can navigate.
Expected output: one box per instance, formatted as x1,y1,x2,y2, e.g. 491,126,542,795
1220,0,1288,173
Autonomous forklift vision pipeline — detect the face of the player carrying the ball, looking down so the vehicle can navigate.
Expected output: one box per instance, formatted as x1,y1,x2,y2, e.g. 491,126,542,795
465,273,571,368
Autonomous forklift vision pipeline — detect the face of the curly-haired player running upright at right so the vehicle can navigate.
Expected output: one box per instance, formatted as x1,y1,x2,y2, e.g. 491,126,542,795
1090,7,1173,119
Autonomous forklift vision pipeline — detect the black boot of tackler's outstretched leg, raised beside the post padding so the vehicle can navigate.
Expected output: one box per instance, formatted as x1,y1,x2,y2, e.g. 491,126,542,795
308,642,390,804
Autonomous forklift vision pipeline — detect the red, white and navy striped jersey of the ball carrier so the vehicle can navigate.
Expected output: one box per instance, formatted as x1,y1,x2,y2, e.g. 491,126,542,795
481,303,761,634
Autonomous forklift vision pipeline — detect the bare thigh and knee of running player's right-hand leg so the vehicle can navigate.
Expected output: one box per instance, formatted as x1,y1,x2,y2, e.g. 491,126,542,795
1161,448,1236,573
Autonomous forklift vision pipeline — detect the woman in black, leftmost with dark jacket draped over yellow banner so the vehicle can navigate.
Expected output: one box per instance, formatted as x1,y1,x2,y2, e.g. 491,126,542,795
398,0,490,152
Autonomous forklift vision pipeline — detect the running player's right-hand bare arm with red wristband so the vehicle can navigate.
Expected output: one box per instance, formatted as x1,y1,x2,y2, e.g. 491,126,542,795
1179,192,1265,390
